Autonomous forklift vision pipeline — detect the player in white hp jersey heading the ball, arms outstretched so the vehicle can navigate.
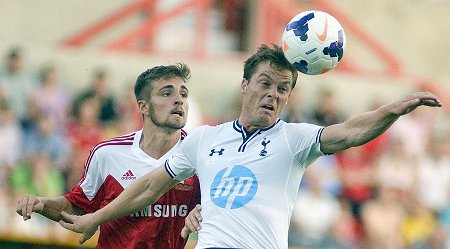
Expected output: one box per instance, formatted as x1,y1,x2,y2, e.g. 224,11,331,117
60,45,441,249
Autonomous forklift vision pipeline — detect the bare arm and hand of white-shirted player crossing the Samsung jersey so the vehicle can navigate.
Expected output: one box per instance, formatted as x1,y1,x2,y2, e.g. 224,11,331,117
59,166,178,244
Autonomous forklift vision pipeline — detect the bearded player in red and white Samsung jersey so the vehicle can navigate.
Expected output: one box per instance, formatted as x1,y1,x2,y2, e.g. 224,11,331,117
16,63,200,249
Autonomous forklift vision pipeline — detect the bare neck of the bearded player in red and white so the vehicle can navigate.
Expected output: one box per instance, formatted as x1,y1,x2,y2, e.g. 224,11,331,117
139,126,181,159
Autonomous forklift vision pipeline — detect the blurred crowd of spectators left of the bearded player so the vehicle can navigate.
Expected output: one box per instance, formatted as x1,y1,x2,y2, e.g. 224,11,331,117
0,47,142,241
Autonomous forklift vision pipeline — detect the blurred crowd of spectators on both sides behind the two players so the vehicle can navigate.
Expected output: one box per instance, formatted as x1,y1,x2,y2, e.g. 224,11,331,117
0,44,450,249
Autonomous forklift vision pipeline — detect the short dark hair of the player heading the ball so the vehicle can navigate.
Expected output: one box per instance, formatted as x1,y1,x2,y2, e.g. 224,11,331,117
244,44,298,89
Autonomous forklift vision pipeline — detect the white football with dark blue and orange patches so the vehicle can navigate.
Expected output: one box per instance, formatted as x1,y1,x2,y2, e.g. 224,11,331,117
282,10,345,75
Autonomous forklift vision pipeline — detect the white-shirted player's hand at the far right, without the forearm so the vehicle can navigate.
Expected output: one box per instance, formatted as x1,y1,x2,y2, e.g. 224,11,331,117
392,92,442,115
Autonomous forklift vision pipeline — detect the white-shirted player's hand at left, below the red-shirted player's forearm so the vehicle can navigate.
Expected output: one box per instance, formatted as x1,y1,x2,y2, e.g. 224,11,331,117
59,211,98,245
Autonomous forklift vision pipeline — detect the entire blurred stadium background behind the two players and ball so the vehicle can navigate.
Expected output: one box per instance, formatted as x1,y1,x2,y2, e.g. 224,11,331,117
0,0,450,249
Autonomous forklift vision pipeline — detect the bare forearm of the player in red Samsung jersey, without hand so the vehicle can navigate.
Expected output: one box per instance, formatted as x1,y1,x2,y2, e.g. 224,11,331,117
38,196,80,221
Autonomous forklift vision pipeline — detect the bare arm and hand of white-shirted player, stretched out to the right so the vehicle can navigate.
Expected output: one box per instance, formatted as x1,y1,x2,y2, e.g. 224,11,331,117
320,92,442,154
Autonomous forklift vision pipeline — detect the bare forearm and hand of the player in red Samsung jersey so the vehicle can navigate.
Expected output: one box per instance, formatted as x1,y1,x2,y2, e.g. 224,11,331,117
16,195,84,221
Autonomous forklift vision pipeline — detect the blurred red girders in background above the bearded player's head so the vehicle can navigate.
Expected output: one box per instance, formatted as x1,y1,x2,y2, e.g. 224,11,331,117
63,0,212,57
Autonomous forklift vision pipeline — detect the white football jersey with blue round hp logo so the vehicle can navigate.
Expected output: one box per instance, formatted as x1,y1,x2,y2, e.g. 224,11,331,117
165,120,324,249
